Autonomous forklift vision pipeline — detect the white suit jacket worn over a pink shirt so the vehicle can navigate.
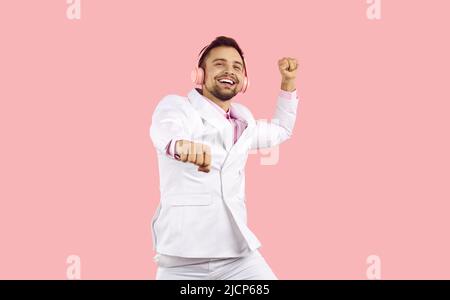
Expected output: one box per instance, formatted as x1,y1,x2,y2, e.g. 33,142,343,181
150,88,298,258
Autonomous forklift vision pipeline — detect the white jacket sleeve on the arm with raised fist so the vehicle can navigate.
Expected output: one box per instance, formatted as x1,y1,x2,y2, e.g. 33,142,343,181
250,91,299,149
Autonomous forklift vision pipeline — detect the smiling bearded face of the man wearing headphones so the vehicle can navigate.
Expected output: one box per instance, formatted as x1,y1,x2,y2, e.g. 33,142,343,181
203,46,244,101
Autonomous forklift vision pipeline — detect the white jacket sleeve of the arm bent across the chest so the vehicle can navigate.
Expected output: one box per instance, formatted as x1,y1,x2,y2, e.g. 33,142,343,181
150,95,192,159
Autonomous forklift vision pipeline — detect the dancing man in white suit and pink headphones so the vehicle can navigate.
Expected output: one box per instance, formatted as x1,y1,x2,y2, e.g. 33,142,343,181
150,36,298,280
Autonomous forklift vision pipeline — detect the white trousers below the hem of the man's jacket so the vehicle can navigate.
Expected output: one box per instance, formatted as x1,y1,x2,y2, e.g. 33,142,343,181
156,249,278,280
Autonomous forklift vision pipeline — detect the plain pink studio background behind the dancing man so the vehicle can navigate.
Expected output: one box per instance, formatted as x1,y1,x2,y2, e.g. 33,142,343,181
0,0,450,279
